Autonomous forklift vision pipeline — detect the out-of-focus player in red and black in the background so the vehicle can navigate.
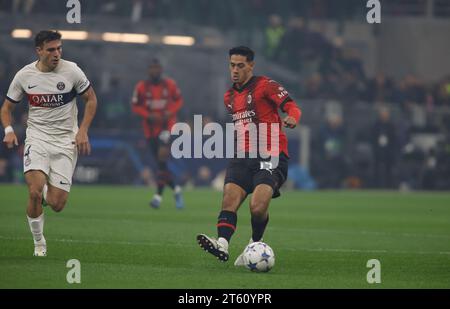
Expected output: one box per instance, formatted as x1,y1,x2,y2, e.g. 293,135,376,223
131,59,184,209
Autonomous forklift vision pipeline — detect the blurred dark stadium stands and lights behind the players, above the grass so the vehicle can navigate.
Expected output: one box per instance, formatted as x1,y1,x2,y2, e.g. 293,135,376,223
0,0,450,190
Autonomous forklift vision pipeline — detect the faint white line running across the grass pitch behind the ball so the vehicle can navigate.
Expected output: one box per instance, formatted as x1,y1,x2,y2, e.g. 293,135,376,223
0,235,450,255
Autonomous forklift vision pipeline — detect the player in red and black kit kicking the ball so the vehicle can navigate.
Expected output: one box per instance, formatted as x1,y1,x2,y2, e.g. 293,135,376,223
197,46,301,266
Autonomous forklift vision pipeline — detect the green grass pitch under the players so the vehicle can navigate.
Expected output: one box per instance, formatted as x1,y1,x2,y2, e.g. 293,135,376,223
0,185,450,289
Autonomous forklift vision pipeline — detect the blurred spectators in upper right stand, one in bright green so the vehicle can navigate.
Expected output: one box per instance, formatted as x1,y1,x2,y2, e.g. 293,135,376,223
264,15,450,108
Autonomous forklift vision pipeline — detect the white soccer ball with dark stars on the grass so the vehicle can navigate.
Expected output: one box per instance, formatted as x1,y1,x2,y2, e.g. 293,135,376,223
244,242,275,272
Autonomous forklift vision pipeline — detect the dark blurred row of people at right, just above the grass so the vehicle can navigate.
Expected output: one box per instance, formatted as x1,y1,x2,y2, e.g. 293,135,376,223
311,105,450,190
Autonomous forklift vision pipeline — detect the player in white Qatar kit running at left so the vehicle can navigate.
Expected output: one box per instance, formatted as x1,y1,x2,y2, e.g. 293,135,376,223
1,30,97,256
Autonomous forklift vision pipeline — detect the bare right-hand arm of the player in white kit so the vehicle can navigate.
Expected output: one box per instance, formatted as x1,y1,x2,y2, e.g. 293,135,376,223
75,87,97,155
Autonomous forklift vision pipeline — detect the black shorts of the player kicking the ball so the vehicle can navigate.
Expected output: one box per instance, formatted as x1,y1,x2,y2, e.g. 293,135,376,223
225,153,289,198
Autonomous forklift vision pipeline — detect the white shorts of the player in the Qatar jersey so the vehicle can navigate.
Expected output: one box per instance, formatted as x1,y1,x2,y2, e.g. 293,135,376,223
23,139,78,192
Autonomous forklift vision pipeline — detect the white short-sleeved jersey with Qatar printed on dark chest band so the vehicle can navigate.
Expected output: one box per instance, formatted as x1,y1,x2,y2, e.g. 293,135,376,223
6,59,90,144
